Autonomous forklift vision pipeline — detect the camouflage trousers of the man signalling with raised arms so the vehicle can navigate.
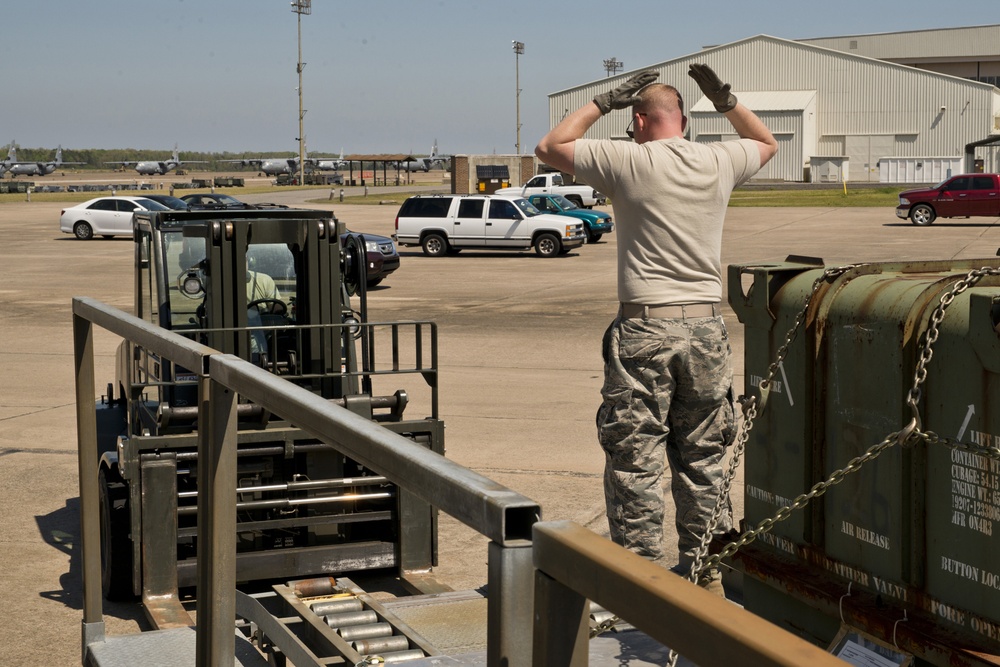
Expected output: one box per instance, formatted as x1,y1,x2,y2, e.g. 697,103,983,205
597,317,735,567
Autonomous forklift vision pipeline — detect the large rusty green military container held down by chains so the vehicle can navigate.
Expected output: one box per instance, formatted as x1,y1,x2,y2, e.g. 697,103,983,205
729,258,1000,665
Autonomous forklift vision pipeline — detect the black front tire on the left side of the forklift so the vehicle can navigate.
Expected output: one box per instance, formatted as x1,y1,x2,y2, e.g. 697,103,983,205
98,468,135,601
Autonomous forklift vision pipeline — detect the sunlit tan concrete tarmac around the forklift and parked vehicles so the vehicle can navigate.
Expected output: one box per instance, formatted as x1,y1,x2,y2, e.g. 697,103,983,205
0,188,1000,665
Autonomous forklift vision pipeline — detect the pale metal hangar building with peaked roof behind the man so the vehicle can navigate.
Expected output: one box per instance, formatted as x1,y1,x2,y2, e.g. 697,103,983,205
549,25,1000,183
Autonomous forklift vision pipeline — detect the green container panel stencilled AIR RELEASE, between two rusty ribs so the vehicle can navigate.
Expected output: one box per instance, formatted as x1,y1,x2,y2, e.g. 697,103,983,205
815,265,955,582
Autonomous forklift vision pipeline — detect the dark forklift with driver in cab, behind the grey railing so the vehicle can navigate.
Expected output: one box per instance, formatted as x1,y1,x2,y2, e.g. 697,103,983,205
94,209,444,628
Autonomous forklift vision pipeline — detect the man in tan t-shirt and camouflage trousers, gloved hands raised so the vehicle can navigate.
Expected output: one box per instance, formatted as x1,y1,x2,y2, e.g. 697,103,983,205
535,64,778,594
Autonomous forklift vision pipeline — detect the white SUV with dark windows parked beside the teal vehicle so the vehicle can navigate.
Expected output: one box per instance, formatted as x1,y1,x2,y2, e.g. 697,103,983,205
393,195,587,257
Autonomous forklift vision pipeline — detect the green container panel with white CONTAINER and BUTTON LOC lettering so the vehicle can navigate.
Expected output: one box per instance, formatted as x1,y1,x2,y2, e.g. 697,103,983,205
922,288,1000,638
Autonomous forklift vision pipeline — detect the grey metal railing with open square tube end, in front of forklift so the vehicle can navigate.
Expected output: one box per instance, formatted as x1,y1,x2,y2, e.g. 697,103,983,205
73,297,541,666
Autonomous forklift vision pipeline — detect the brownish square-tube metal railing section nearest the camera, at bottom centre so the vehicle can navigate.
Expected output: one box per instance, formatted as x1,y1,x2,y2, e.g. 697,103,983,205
532,521,844,667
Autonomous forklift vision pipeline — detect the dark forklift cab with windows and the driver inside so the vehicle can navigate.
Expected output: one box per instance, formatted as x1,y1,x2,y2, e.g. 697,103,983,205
129,209,367,434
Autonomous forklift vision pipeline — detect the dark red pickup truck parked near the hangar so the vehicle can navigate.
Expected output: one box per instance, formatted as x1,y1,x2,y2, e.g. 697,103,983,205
896,174,1000,225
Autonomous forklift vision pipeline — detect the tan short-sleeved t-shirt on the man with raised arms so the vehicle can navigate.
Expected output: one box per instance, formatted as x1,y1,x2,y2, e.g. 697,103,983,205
574,138,760,305
